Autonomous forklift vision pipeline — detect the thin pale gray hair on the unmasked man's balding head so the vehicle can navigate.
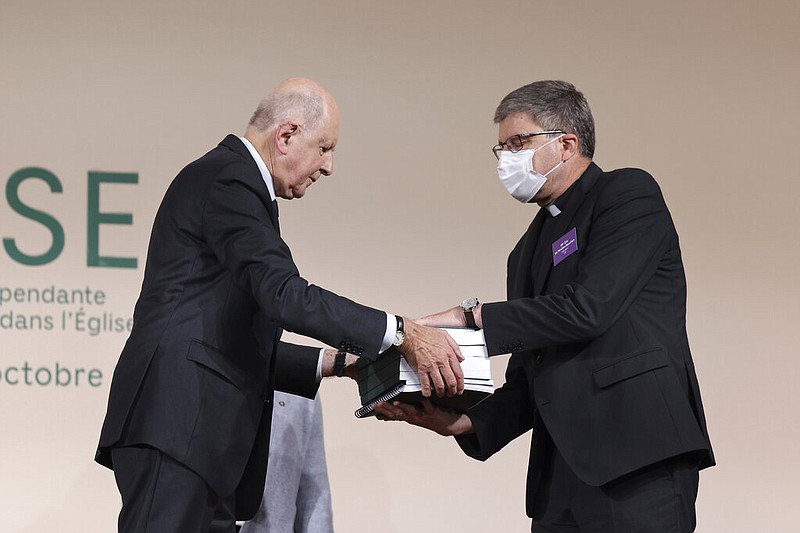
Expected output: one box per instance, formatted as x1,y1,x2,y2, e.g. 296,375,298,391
248,91,325,131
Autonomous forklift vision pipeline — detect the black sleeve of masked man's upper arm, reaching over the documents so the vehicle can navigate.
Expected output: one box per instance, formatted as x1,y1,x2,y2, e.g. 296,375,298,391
482,170,674,354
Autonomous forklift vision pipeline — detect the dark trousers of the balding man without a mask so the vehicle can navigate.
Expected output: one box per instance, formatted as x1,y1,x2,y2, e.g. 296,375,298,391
111,446,235,533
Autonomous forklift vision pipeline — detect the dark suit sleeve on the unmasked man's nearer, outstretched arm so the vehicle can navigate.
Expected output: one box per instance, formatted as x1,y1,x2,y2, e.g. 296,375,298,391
203,163,386,358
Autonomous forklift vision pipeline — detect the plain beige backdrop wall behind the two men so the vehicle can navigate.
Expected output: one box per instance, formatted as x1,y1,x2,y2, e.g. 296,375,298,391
0,0,800,533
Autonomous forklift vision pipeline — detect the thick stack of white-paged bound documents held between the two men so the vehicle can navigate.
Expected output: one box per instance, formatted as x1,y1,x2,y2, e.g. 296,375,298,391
355,328,494,418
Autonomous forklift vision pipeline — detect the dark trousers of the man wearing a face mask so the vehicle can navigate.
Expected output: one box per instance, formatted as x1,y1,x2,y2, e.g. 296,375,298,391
531,451,699,533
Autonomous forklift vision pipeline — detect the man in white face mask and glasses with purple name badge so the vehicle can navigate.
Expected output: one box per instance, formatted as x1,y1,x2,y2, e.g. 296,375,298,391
376,81,714,533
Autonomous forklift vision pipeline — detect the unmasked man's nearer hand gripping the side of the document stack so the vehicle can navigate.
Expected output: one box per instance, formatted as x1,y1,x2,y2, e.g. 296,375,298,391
398,319,464,397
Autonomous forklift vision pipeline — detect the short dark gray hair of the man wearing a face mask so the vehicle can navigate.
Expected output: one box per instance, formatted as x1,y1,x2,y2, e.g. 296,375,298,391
494,80,594,159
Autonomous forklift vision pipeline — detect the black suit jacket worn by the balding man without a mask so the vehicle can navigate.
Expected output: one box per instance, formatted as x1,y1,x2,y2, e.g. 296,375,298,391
97,135,386,518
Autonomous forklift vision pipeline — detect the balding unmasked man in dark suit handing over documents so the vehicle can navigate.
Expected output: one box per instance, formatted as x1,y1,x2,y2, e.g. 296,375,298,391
97,78,463,533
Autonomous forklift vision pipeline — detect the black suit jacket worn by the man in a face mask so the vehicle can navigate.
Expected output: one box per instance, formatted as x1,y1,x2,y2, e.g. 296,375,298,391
458,163,714,516
